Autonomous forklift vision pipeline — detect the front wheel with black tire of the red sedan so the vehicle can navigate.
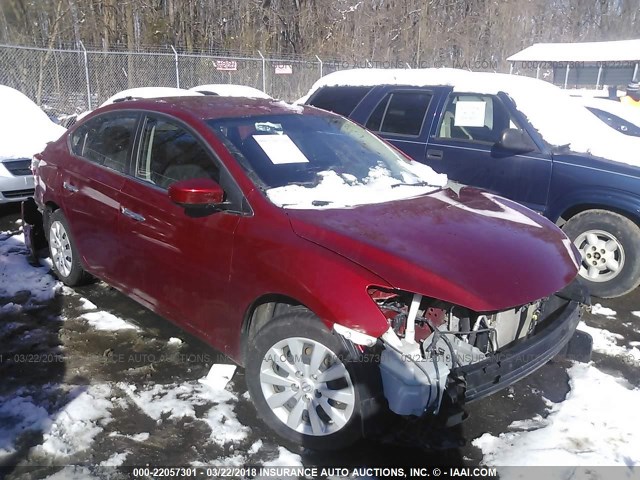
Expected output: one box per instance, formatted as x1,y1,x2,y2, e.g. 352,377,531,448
246,310,386,450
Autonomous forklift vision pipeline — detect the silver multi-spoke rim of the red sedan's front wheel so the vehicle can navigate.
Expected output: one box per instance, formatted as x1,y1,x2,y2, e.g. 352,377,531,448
260,337,356,436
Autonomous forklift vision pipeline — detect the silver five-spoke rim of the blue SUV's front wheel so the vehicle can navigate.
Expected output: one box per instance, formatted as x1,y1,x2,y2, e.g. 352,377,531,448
573,230,625,283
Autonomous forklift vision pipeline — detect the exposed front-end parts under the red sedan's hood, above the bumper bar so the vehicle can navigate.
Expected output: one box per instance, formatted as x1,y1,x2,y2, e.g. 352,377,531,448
369,290,542,416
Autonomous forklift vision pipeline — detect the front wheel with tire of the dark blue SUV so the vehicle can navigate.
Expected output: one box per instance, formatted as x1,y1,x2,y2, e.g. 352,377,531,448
563,210,640,298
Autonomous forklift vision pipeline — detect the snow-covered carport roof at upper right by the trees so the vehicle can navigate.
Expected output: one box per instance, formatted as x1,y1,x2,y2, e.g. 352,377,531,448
507,39,640,62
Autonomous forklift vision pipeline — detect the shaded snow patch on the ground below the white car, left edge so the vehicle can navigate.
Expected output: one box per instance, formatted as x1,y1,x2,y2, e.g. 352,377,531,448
0,234,61,303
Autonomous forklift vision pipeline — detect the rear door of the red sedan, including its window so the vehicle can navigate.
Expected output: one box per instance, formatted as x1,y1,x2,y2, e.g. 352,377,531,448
60,112,139,284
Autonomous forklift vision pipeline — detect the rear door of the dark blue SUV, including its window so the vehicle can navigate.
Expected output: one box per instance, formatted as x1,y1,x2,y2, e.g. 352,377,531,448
349,86,437,161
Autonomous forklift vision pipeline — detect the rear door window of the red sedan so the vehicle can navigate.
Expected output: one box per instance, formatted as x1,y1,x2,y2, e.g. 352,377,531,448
71,114,138,173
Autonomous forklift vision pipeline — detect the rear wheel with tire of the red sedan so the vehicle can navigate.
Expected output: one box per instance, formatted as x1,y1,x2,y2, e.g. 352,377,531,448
47,210,91,287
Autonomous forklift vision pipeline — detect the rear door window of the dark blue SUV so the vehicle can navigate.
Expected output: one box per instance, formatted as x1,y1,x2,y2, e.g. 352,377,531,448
366,92,432,136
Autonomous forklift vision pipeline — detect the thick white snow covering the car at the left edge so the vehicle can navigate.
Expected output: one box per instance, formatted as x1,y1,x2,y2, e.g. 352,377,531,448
0,85,66,160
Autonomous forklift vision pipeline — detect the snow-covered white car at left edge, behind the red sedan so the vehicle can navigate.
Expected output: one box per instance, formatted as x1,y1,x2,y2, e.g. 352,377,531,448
0,85,66,204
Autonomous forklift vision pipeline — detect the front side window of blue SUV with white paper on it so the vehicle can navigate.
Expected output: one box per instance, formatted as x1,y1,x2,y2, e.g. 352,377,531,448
437,93,522,144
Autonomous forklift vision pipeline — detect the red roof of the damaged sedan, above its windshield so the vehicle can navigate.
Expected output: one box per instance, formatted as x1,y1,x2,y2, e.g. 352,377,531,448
96,95,312,120
